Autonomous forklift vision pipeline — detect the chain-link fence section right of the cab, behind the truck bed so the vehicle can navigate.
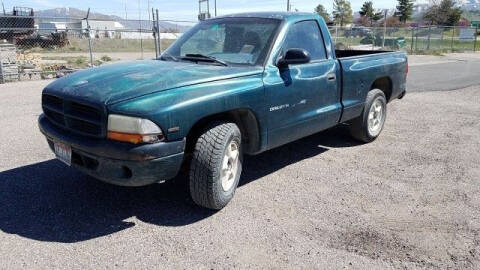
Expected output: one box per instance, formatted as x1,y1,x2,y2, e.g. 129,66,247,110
329,26,480,54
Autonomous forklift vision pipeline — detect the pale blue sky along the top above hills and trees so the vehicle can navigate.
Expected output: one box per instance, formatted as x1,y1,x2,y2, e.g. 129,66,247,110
3,0,423,21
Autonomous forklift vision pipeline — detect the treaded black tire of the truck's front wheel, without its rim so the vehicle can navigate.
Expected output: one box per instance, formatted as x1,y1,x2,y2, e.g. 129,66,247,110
189,122,243,210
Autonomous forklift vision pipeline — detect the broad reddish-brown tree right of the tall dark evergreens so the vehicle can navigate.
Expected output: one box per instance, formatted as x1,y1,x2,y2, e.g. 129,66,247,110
423,0,462,26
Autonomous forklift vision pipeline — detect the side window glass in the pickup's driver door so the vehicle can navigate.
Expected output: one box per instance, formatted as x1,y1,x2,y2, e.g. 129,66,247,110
283,21,327,60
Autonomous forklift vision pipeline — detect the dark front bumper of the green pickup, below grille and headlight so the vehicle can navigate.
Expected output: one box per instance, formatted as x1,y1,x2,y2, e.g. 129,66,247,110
38,114,185,186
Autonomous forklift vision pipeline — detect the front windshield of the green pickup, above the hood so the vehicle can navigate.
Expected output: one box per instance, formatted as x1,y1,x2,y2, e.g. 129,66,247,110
162,18,280,65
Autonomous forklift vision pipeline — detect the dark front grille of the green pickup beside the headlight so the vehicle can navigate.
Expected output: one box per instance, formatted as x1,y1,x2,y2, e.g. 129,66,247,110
42,94,105,137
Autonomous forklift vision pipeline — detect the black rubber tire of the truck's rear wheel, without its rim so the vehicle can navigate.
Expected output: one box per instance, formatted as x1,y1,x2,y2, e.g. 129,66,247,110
349,89,387,143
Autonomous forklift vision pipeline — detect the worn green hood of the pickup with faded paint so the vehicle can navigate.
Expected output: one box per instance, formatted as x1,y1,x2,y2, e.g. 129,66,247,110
44,60,263,105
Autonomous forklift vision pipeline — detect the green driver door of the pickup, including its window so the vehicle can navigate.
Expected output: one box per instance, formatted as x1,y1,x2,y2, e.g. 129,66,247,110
264,20,341,149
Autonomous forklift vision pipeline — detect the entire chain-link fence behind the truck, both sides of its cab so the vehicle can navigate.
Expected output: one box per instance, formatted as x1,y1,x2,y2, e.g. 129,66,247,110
0,8,480,83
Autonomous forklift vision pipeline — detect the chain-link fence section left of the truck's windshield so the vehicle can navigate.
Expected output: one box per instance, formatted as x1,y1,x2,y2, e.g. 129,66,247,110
0,11,195,83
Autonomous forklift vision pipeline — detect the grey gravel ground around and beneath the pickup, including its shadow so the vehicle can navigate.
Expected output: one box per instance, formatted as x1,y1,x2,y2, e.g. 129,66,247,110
0,79,480,269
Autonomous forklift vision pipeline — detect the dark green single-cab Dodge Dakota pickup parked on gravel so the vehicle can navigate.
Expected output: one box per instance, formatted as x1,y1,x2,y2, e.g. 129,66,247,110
38,13,408,209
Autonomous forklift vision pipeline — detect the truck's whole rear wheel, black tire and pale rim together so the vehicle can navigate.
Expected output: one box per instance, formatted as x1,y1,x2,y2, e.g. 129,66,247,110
350,89,387,143
